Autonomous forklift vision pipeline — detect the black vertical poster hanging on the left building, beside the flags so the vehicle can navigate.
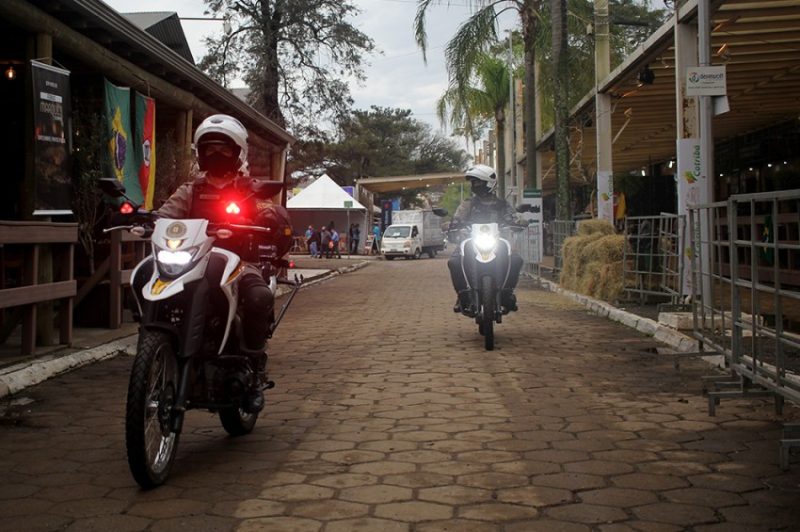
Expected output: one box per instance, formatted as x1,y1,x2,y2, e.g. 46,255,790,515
31,61,72,216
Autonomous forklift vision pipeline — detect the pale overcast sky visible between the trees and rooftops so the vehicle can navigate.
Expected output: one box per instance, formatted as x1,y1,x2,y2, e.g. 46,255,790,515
104,0,518,133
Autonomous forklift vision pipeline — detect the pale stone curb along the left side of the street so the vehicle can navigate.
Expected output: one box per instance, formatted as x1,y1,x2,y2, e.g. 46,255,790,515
0,261,370,399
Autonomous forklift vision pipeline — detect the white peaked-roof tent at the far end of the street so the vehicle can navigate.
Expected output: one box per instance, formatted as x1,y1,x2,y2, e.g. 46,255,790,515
286,174,370,252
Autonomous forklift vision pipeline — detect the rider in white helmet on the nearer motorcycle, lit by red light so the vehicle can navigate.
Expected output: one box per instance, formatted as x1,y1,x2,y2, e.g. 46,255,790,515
142,114,291,413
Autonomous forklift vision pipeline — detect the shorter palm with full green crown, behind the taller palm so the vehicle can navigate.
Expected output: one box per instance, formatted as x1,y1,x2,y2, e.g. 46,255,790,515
437,54,509,198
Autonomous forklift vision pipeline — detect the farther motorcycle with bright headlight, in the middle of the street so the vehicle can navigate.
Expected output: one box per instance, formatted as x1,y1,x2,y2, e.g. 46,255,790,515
449,223,522,351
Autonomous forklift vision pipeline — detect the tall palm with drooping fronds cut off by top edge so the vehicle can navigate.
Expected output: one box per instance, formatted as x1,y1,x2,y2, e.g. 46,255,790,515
414,0,544,193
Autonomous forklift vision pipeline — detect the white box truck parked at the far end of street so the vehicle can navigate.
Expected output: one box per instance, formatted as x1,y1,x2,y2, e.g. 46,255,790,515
381,209,447,260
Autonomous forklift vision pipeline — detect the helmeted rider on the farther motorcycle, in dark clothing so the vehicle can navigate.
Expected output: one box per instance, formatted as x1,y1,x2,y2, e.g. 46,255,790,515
447,164,523,316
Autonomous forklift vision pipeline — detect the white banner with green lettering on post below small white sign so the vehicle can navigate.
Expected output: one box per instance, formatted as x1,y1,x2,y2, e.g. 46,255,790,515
677,139,709,294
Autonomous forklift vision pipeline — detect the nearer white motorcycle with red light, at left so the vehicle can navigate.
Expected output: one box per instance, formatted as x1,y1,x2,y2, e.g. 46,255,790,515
101,179,302,488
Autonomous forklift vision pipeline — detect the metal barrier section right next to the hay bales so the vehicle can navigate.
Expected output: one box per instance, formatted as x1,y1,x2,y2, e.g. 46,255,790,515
622,213,685,304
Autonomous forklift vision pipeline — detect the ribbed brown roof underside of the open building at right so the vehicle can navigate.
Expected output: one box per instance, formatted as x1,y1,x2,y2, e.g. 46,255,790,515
539,0,800,188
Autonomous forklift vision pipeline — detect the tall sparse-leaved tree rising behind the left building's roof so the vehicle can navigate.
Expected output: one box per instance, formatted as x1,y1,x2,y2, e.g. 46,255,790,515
198,0,375,137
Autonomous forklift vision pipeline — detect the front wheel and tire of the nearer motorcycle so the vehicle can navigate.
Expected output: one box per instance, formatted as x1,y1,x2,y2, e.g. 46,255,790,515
125,330,180,489
